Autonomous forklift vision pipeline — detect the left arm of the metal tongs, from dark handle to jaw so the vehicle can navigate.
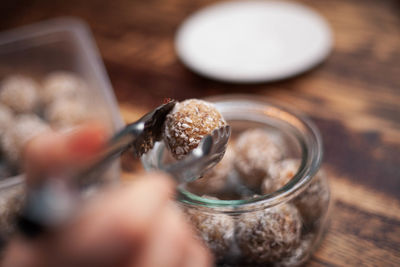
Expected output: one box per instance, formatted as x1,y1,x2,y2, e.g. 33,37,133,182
16,101,175,238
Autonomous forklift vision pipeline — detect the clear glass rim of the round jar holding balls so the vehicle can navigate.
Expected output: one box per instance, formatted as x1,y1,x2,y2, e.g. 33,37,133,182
142,94,323,214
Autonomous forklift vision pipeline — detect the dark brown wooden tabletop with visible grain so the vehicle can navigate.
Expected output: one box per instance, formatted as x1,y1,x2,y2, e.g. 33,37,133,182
0,0,400,266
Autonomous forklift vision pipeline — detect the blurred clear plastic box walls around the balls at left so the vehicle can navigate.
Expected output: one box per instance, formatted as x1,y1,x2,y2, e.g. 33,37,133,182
0,18,124,245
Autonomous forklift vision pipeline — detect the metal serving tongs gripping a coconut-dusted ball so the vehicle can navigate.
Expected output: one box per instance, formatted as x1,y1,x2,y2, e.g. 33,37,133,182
17,102,230,238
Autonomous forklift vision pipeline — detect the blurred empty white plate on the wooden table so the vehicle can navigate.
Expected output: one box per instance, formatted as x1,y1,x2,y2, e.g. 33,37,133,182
175,1,332,83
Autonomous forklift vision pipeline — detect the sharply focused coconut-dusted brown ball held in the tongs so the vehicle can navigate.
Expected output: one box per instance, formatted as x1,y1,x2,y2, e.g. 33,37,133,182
164,99,226,159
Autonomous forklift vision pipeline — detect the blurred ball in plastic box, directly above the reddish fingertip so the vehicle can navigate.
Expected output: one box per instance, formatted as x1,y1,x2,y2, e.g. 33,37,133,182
45,98,90,129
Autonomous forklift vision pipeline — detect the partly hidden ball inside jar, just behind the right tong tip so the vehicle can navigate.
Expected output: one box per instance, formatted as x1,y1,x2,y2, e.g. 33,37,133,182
186,144,235,195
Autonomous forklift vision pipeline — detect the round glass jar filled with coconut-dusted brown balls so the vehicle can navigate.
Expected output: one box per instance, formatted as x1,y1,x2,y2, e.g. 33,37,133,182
142,95,330,266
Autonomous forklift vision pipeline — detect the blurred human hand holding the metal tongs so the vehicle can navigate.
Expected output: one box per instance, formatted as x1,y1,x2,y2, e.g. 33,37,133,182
2,124,211,267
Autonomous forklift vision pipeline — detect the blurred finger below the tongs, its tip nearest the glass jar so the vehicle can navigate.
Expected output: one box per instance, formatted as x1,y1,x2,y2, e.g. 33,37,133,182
5,173,174,267
